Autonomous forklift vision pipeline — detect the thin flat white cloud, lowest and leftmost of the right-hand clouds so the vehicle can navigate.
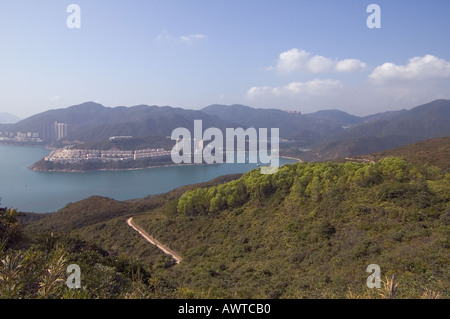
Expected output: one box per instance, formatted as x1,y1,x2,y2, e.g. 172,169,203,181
247,79,343,99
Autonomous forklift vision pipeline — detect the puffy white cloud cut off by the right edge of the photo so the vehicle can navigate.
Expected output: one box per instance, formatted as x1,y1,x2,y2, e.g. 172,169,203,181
369,55,450,83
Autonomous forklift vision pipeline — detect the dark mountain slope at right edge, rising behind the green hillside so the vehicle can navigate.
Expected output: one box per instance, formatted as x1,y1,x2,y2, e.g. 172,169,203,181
299,100,450,161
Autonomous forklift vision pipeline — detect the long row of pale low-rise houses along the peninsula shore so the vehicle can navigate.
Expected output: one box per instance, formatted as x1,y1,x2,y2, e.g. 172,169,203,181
44,148,171,164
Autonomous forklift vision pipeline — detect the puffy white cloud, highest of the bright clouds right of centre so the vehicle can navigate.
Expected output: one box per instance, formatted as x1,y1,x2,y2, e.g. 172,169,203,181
269,48,367,73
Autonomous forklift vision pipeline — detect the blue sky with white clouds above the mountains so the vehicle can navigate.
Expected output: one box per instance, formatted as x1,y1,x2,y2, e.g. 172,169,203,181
0,0,450,117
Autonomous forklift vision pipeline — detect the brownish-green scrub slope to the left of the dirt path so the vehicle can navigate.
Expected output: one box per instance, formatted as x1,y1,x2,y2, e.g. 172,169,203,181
0,174,244,299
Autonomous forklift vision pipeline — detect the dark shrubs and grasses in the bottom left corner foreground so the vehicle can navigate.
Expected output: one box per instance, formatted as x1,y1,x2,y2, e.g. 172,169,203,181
0,209,153,299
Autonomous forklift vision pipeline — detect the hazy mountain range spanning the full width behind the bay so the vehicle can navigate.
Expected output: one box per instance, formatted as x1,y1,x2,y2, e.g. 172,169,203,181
2,99,450,161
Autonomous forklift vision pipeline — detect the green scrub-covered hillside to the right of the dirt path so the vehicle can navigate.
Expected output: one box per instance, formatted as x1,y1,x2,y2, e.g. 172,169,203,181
129,157,450,298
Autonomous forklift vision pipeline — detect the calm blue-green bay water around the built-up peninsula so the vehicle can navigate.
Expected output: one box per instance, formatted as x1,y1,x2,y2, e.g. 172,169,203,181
0,145,295,213
